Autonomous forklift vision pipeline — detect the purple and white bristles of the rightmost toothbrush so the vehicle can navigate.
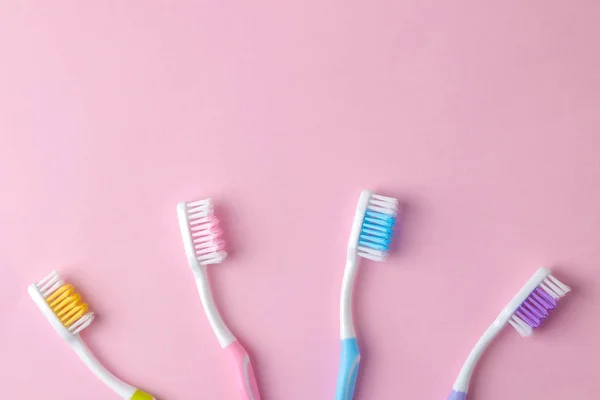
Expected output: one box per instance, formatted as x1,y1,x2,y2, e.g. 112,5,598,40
509,275,571,337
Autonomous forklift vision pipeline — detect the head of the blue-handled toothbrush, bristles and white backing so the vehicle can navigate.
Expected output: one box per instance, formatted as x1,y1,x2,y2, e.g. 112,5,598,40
348,190,398,261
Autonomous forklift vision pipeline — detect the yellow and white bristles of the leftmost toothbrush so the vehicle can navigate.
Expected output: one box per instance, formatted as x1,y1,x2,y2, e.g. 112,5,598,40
36,271,94,335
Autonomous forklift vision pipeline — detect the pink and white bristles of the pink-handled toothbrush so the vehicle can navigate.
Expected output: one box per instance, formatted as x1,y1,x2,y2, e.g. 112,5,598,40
186,199,227,265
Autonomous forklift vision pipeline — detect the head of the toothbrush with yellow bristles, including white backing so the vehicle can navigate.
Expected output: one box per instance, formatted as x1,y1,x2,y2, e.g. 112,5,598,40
28,271,94,338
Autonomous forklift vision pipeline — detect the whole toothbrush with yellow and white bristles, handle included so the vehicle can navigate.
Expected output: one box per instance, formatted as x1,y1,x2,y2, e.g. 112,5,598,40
27,271,156,400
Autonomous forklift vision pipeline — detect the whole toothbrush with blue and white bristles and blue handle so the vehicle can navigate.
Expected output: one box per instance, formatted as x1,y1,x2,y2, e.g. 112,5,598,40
335,190,398,400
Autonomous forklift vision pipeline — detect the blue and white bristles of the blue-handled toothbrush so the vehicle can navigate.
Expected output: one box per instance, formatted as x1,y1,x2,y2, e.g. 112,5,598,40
358,194,398,261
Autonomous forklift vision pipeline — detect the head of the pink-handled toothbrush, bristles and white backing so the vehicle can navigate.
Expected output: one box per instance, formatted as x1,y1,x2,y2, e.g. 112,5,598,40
177,199,227,266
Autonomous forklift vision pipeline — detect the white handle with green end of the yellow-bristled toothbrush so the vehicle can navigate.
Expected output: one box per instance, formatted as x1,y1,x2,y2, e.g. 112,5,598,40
69,335,154,400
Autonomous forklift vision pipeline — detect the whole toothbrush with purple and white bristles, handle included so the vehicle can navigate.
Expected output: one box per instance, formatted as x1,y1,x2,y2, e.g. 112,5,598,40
448,268,571,400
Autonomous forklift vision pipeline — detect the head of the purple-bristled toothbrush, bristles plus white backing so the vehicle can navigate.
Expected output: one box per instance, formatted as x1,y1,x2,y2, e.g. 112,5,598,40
508,268,571,337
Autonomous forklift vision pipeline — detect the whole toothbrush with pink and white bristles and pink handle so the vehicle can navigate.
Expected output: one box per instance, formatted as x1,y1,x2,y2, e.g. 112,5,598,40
177,199,260,400
